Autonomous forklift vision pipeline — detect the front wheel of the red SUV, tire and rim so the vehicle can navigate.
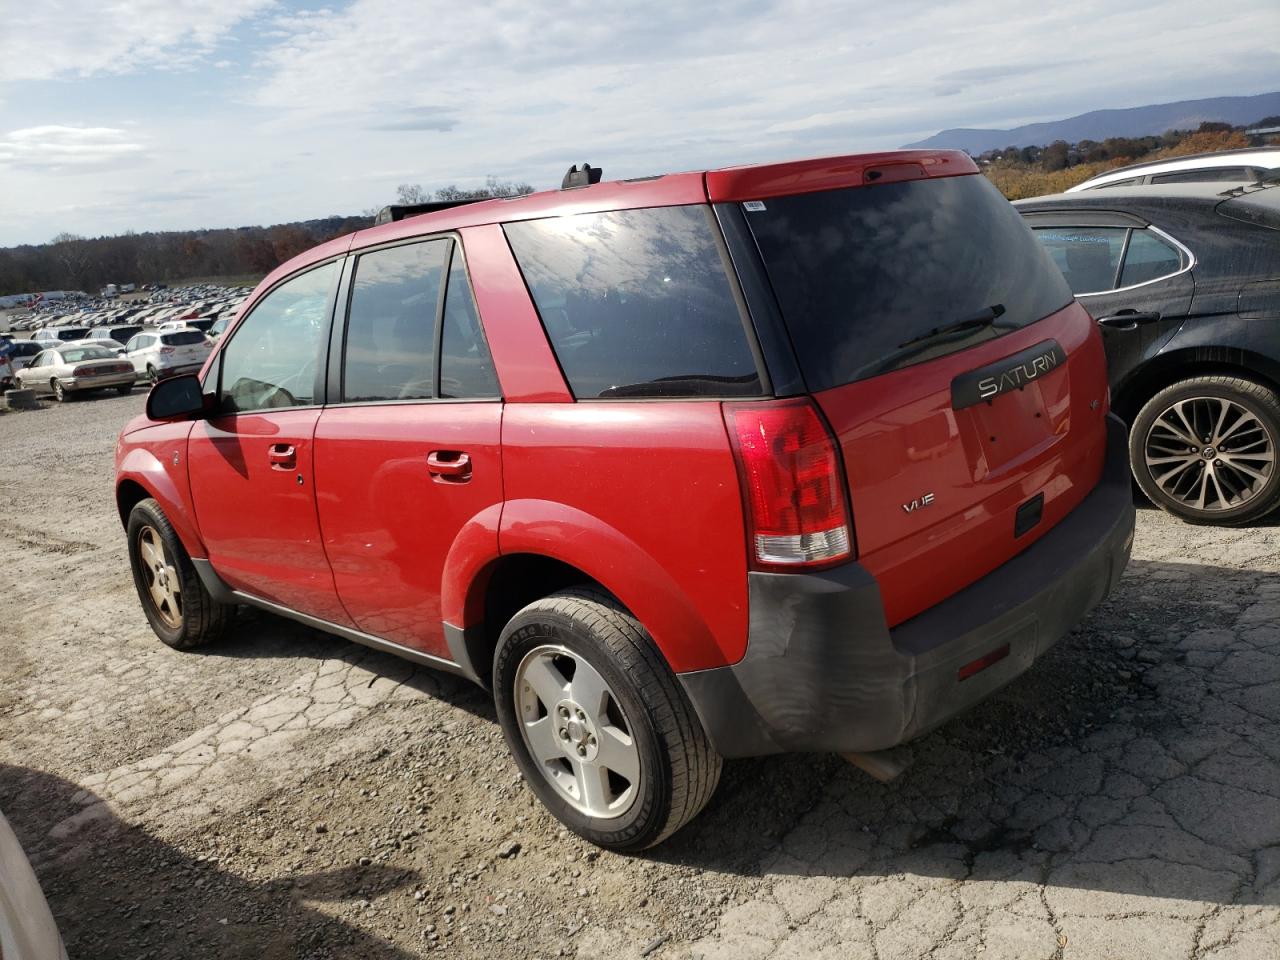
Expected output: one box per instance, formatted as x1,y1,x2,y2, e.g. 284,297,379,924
128,498,234,650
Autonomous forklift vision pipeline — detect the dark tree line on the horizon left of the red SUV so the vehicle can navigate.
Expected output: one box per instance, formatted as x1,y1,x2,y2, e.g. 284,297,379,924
0,177,534,296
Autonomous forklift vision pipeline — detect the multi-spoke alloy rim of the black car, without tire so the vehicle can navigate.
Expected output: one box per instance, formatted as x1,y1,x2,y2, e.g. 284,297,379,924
1143,397,1276,513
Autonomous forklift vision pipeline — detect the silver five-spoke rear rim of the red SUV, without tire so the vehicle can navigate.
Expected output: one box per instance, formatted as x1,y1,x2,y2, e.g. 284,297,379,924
515,644,640,819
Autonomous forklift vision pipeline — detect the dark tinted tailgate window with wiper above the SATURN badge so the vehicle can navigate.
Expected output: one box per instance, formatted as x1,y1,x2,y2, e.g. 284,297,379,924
744,175,1071,390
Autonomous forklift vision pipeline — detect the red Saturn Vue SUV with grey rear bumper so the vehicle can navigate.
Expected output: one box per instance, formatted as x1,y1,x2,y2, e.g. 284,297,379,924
116,151,1134,849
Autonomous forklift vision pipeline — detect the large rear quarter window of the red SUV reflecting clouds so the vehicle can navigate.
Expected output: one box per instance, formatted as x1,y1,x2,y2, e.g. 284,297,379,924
504,206,762,398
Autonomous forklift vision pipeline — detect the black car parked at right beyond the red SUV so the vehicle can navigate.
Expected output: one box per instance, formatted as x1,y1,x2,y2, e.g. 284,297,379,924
1015,183,1280,525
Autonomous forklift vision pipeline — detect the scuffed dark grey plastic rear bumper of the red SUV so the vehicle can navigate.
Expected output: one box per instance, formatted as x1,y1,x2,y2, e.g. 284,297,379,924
678,416,1134,756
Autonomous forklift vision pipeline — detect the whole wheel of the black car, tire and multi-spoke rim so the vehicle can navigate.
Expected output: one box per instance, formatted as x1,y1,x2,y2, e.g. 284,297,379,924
1129,376,1280,526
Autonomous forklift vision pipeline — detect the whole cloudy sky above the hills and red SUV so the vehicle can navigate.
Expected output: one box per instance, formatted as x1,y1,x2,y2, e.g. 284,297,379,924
0,0,1280,246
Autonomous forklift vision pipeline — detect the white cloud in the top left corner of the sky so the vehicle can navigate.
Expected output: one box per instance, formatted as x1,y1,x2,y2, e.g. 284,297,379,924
0,0,274,82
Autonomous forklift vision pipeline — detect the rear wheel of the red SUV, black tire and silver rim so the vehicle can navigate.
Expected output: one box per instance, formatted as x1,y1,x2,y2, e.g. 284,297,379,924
493,588,722,851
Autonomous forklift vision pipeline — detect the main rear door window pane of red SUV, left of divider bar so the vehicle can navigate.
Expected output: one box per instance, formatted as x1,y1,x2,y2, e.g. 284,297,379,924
342,239,451,402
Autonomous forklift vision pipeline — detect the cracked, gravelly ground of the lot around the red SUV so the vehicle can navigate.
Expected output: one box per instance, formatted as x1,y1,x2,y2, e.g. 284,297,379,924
0,392,1280,960
